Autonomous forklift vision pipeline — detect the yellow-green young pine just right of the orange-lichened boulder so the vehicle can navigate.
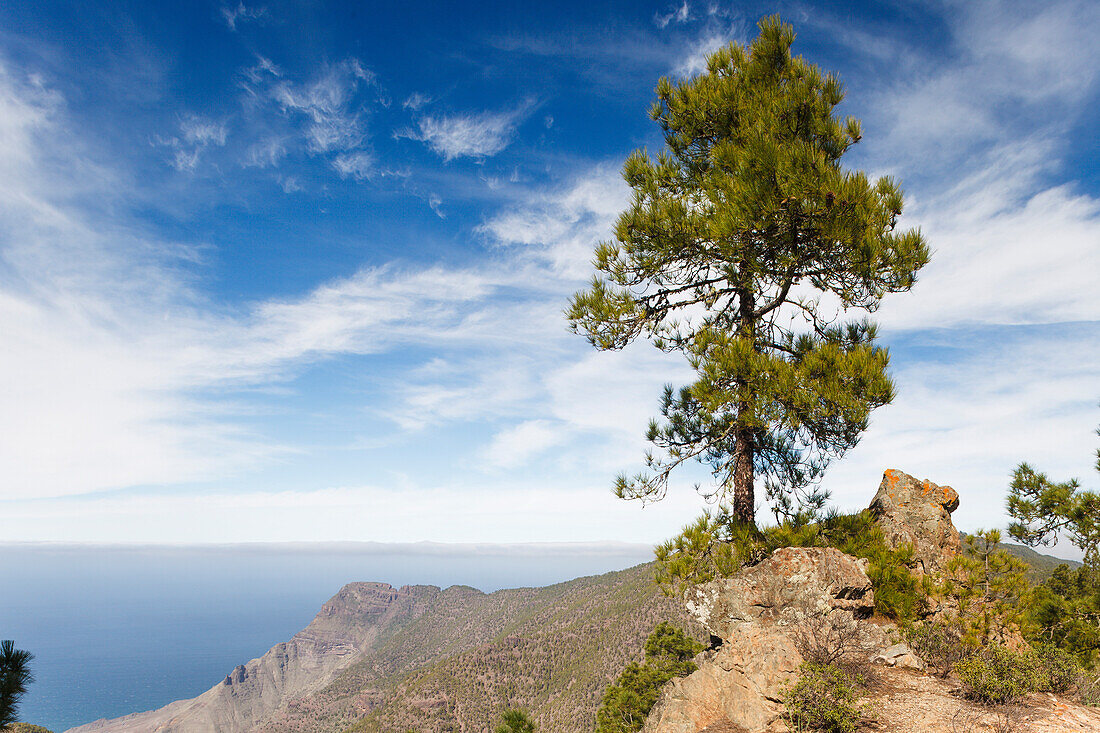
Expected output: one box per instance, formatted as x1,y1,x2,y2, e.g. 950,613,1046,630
943,529,1030,646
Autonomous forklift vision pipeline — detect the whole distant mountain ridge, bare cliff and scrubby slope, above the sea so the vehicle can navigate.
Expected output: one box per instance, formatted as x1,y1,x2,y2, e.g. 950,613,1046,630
62,566,686,733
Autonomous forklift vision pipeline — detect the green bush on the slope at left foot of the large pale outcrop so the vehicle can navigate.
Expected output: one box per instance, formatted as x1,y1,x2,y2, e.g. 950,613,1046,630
596,622,703,733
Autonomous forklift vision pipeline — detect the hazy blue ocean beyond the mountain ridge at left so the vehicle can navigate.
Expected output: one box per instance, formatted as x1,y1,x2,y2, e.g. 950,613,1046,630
0,543,652,733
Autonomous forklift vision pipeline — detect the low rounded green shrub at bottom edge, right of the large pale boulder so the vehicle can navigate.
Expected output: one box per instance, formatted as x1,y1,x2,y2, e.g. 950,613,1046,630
783,663,868,733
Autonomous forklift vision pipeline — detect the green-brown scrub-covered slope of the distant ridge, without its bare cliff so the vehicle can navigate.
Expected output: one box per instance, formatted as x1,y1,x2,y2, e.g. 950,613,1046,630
261,565,688,732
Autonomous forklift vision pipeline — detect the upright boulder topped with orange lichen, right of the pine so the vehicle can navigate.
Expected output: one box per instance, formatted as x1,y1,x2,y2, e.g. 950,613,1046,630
868,469,959,573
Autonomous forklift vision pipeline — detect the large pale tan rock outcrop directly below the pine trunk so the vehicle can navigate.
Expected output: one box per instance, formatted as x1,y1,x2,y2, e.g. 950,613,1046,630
644,547,875,733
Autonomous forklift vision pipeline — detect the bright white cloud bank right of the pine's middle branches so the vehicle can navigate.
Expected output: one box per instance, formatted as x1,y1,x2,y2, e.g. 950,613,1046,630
879,152,1100,328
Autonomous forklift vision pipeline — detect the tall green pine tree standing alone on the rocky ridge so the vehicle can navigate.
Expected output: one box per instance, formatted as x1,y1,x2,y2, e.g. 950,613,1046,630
568,18,928,522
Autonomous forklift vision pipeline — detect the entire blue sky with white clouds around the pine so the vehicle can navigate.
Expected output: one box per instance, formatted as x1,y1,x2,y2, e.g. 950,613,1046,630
0,2,1100,543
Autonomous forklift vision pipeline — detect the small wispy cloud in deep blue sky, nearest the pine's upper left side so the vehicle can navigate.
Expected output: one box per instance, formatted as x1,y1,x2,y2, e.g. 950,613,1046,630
413,105,530,161
